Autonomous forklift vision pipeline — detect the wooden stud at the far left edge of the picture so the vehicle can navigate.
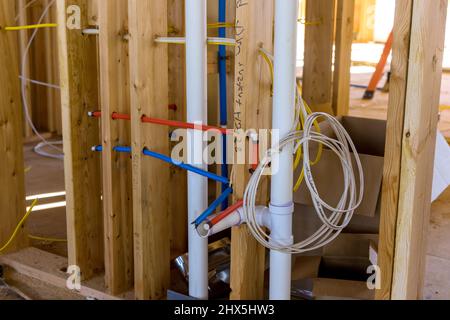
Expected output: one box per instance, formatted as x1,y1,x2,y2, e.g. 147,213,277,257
0,1,28,253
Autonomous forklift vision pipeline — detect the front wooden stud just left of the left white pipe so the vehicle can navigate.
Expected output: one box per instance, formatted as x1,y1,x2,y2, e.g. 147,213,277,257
128,0,171,299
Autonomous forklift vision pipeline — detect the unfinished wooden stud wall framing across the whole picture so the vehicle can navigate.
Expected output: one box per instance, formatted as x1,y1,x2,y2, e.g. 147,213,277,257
0,0,448,299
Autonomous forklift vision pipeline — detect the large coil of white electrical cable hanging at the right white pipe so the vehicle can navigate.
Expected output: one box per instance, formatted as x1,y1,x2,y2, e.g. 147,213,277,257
243,92,364,254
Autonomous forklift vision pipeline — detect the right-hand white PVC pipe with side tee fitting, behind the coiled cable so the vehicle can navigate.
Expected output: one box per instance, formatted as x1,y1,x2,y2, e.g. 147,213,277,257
270,0,298,300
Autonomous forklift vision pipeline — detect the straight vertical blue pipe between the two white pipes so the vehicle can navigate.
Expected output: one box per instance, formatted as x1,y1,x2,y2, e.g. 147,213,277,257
219,0,228,209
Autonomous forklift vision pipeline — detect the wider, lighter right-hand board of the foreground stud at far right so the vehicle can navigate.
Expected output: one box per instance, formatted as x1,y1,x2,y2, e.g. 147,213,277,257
391,0,448,300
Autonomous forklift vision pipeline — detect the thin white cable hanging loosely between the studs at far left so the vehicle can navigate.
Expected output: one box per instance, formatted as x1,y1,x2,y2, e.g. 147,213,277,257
20,0,64,159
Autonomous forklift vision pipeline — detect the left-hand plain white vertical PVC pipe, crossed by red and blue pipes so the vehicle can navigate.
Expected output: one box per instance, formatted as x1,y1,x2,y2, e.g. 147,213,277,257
185,0,208,299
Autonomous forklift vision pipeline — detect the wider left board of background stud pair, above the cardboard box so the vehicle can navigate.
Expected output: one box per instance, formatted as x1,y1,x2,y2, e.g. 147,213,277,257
303,0,335,113
